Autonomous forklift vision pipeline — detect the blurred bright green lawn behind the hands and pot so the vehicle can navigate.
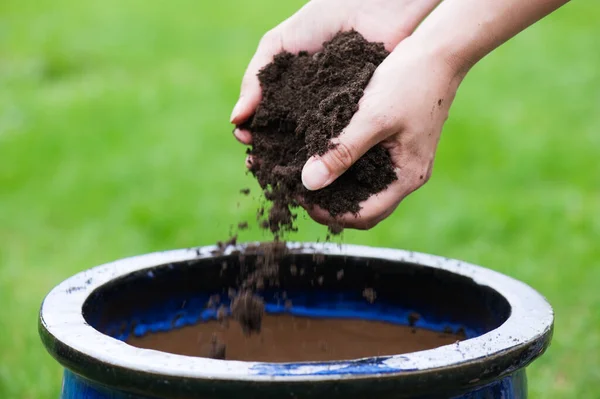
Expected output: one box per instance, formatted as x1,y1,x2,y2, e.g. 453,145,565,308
0,0,600,399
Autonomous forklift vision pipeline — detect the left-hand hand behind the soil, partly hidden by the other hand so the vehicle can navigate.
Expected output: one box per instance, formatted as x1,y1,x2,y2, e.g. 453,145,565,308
231,0,441,140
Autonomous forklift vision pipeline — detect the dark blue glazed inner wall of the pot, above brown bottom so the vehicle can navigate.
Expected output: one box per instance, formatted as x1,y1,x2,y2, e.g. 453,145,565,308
83,248,510,361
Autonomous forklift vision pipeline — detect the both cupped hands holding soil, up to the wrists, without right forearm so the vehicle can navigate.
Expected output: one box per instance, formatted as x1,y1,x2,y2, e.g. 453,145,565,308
231,0,466,229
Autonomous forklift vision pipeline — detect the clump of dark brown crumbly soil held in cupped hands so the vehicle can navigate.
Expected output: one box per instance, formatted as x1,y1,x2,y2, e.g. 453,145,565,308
240,31,397,234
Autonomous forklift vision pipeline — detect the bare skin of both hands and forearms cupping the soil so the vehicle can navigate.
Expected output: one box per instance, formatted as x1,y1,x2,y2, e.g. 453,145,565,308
231,0,568,229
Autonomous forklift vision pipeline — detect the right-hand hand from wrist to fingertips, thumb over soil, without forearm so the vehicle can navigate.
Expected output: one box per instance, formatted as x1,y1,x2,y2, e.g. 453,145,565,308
302,38,466,229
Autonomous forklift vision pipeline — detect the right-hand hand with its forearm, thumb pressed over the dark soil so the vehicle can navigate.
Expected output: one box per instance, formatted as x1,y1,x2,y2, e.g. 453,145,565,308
302,0,567,229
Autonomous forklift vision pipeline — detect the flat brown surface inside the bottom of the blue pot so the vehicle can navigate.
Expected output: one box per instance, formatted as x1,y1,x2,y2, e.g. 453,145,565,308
127,315,464,362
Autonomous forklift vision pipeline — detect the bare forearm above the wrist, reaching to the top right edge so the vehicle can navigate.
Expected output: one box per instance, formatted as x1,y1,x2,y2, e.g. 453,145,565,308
413,0,569,72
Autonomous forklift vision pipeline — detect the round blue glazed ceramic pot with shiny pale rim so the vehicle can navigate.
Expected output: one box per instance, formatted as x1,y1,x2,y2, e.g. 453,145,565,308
39,244,553,399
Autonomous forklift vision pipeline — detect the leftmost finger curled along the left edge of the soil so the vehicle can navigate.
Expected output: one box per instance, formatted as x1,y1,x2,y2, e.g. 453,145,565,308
230,31,282,125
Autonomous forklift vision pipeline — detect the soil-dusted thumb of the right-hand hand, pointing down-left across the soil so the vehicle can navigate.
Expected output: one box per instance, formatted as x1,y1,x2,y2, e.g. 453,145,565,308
302,110,384,191
